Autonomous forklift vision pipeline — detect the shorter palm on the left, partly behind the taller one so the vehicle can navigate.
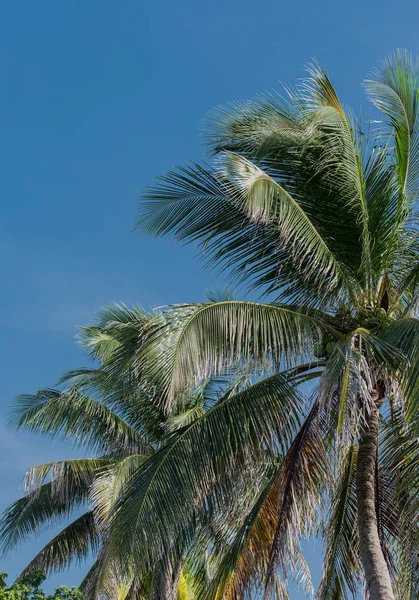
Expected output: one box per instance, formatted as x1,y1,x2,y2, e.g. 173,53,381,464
0,305,211,600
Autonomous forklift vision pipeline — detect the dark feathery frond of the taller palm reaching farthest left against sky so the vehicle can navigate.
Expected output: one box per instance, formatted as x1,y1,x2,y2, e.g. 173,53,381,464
138,159,348,304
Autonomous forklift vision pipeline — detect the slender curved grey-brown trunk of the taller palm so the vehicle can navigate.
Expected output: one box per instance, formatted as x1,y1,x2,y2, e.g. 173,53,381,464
356,394,394,600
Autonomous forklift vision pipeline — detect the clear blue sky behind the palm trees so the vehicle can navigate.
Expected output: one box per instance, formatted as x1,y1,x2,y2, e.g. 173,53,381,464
0,0,419,600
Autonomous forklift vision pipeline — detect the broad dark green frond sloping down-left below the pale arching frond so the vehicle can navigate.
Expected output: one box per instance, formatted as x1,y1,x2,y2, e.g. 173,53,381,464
106,374,299,564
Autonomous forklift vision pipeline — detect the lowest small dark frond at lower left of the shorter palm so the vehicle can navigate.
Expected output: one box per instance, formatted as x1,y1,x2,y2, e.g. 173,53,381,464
19,512,100,579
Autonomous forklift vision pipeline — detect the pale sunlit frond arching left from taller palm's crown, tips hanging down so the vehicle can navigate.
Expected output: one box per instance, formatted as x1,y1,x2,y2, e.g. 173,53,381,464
138,301,328,410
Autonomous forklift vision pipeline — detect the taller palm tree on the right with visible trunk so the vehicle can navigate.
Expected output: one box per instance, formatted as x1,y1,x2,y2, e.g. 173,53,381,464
114,51,419,600
